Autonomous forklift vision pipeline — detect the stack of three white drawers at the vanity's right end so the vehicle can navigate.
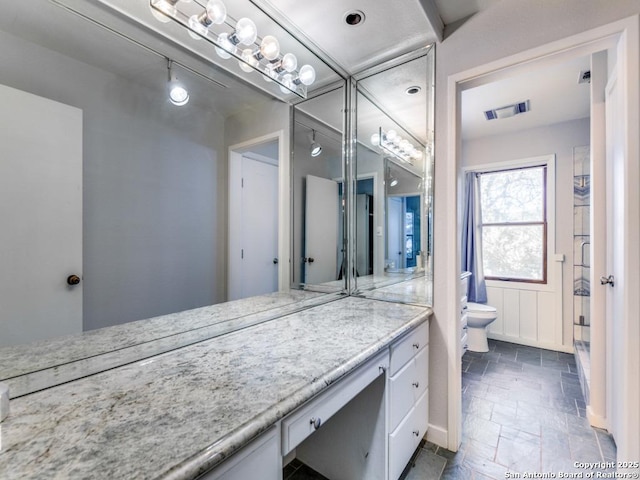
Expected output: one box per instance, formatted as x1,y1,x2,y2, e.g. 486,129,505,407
388,322,429,480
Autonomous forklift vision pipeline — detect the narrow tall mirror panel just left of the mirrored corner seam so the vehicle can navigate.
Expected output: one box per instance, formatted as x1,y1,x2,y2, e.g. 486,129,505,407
292,84,345,291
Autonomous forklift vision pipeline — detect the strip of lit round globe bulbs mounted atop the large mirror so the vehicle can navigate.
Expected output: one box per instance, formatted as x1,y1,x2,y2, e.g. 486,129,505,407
149,0,316,98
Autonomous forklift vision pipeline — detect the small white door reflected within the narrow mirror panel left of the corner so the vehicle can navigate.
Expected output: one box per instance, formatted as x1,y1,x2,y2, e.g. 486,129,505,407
304,175,340,285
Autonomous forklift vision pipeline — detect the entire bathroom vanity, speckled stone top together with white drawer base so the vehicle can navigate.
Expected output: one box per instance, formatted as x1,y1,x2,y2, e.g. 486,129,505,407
0,296,431,480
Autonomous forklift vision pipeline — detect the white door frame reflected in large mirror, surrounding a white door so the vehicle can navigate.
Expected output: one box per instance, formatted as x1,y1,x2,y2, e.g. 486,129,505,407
225,130,291,298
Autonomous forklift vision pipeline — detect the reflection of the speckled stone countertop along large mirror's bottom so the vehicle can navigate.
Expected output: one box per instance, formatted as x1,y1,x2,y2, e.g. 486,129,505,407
0,290,330,398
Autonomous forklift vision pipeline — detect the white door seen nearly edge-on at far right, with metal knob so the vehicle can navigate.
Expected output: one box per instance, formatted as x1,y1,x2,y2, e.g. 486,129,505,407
600,68,627,438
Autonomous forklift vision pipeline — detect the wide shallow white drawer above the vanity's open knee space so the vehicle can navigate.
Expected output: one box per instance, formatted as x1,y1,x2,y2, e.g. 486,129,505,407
282,350,389,455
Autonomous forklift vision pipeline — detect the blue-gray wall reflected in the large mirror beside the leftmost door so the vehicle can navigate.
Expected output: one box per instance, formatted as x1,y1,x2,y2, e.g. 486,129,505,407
0,32,226,329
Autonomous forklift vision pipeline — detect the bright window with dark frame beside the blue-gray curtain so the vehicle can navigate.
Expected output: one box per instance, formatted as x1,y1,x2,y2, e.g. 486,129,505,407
480,166,547,283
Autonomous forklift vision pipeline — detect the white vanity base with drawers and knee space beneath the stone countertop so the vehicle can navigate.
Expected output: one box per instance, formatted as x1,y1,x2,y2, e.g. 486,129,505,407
188,322,429,480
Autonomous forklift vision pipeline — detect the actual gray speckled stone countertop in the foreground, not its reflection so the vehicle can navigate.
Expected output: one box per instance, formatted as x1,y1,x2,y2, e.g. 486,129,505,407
0,297,431,480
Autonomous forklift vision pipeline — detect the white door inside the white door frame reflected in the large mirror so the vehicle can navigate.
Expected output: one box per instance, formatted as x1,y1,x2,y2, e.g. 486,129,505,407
240,156,279,298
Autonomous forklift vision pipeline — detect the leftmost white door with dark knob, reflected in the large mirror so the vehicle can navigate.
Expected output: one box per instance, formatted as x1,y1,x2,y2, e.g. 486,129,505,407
0,85,82,346
